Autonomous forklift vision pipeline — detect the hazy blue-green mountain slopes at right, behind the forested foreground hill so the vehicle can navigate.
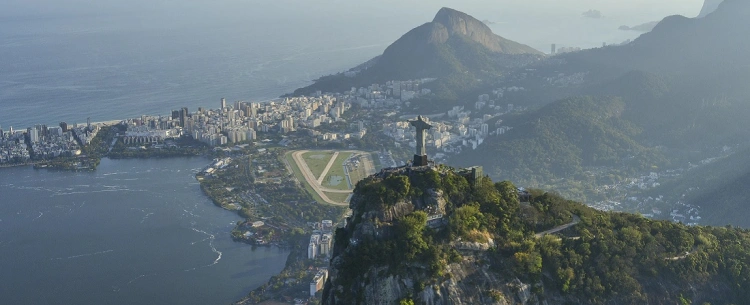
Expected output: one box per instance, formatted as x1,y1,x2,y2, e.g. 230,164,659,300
449,0,750,204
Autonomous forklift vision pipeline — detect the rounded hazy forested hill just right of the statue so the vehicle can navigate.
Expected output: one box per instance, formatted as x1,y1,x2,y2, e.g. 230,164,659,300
451,96,667,185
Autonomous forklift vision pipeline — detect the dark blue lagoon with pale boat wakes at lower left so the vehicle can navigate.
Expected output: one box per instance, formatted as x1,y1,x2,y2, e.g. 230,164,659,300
0,158,288,304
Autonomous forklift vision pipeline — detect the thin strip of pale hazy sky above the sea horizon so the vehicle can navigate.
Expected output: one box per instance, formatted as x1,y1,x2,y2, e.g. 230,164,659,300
0,0,703,17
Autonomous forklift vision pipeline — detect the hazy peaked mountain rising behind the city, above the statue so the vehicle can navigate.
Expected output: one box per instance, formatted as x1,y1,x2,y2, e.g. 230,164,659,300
294,8,544,95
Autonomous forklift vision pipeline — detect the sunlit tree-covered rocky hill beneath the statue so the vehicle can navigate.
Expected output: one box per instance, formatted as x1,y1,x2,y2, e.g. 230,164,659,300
322,166,750,305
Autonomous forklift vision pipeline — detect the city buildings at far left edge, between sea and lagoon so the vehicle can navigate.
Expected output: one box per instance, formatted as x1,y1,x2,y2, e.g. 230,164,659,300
0,122,99,163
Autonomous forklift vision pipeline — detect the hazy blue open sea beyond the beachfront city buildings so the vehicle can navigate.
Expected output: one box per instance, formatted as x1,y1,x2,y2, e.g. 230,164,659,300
0,1,390,130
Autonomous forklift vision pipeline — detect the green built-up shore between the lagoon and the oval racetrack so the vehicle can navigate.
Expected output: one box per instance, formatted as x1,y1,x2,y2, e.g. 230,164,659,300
196,145,345,304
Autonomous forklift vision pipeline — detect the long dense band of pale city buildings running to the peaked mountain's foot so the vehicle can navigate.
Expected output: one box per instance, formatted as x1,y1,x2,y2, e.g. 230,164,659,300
113,78,488,151
